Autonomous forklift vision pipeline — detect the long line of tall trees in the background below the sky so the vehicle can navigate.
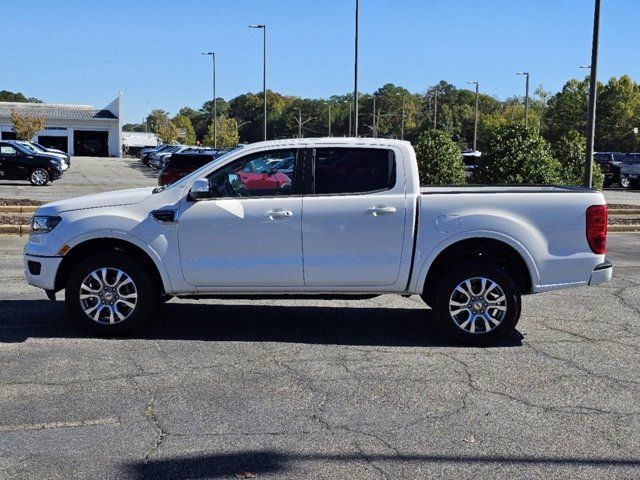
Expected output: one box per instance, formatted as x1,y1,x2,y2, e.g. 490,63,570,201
125,75,640,152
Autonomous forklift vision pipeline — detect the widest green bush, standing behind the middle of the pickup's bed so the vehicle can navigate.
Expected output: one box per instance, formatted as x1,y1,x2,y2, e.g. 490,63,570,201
473,123,560,184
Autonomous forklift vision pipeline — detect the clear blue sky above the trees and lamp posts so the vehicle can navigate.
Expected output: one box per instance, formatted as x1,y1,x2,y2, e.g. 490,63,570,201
0,0,640,122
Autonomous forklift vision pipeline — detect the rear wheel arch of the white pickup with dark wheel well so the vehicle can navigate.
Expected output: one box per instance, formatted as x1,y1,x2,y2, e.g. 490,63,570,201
413,232,540,300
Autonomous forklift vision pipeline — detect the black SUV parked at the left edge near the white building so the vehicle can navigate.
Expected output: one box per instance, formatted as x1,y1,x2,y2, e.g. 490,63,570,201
0,140,62,186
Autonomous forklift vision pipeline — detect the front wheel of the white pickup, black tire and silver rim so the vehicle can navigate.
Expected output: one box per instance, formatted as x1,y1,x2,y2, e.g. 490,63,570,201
65,252,159,336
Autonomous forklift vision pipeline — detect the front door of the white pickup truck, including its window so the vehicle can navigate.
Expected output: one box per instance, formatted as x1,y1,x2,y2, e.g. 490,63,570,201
178,149,304,291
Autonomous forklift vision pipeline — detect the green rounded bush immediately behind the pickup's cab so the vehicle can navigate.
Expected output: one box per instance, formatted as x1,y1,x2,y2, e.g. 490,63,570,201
414,130,465,185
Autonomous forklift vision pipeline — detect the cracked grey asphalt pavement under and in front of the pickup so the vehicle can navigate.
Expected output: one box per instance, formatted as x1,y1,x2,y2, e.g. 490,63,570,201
0,234,640,480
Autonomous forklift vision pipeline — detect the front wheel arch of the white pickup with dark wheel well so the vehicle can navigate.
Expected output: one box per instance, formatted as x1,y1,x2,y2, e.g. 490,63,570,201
55,236,171,293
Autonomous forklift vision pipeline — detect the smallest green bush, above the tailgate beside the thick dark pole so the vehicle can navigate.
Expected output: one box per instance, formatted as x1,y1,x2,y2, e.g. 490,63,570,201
551,130,604,190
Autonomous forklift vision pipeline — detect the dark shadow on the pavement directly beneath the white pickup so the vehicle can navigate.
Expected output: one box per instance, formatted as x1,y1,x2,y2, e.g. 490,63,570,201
0,300,523,347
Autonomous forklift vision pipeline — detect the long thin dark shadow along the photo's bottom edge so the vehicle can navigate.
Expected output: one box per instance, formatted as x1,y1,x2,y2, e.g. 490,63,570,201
122,450,640,479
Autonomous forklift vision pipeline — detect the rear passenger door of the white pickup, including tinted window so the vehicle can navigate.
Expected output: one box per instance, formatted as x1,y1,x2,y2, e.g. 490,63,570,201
302,147,410,289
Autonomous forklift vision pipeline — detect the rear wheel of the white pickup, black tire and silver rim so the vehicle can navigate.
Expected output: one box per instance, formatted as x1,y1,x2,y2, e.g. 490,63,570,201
431,262,522,346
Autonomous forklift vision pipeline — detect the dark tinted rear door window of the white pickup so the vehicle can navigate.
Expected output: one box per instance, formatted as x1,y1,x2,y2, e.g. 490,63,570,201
313,148,396,195
